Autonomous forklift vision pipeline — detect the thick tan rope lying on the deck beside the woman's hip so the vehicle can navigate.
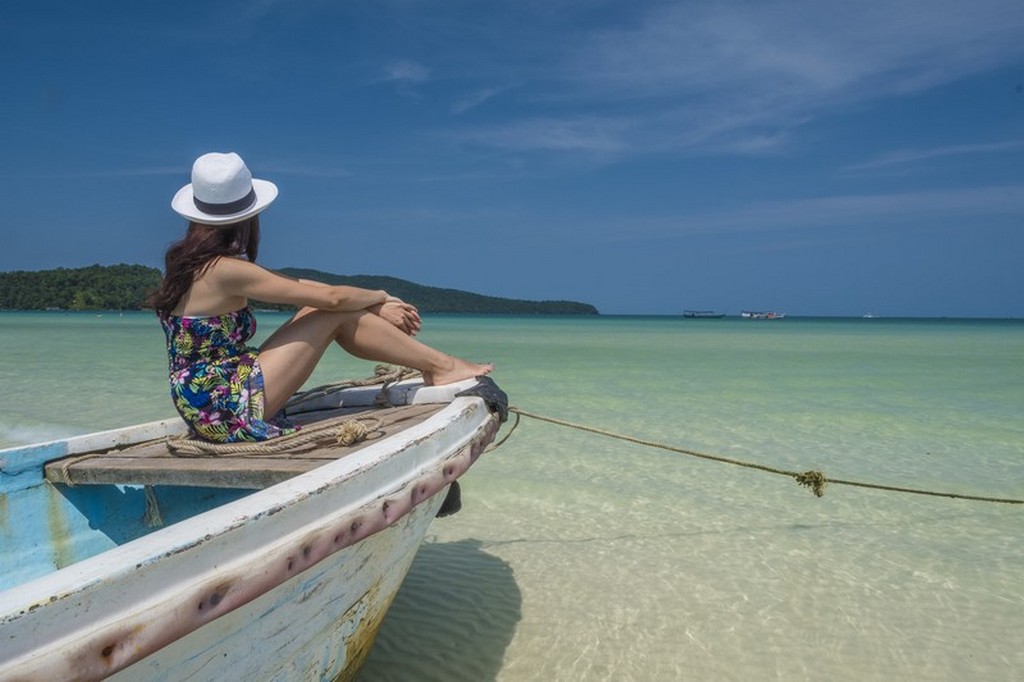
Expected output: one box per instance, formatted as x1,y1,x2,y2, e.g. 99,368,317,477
167,417,382,457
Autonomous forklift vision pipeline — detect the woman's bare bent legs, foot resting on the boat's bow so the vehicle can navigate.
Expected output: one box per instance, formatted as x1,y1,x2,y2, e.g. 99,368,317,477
259,308,494,415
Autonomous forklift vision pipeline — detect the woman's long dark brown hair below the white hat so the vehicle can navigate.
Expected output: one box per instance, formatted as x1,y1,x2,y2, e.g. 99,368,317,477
150,215,259,317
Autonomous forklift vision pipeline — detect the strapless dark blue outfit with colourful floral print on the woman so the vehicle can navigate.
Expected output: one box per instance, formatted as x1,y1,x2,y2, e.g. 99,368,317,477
160,306,298,442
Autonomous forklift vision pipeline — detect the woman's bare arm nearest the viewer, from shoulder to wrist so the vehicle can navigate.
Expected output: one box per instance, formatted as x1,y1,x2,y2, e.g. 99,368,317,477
203,258,388,310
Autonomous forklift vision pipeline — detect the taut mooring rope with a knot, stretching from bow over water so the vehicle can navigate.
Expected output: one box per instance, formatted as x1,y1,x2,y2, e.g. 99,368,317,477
503,407,1024,505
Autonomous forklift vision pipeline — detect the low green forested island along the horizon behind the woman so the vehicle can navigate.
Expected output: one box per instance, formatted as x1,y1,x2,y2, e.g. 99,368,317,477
0,264,598,315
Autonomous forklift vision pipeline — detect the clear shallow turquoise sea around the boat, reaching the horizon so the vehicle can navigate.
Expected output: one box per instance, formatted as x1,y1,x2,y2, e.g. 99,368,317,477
0,312,1024,682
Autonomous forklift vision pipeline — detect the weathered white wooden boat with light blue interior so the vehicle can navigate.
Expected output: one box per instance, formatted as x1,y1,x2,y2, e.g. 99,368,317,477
0,378,507,681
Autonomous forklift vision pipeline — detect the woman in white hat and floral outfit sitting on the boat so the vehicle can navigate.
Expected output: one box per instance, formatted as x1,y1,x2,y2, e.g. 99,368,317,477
151,154,493,442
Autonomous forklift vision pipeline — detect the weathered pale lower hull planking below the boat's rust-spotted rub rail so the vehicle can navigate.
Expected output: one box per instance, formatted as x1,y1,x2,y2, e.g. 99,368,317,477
110,496,441,682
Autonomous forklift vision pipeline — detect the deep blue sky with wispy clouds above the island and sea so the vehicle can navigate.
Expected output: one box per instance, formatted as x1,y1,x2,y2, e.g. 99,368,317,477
0,0,1024,316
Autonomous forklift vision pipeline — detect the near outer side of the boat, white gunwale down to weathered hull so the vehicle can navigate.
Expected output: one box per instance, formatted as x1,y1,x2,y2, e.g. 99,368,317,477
0,397,498,681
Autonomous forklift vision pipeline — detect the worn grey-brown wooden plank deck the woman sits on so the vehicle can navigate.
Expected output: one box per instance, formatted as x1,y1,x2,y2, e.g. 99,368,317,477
45,404,445,489
